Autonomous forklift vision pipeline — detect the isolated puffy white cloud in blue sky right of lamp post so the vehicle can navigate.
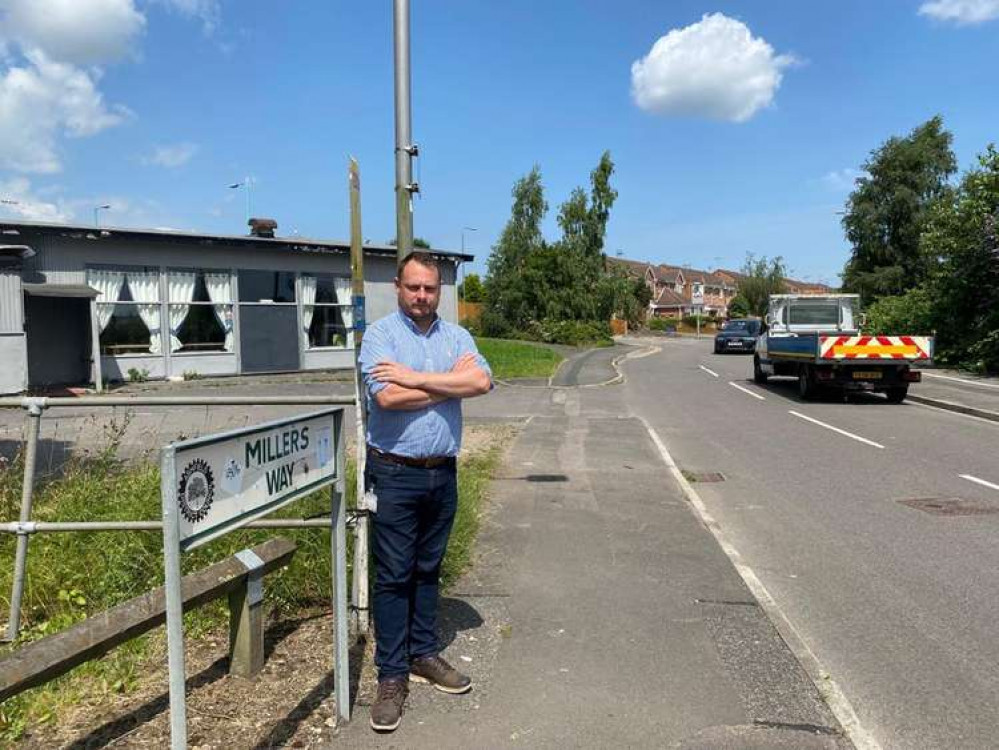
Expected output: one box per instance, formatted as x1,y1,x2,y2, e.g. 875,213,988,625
631,13,796,122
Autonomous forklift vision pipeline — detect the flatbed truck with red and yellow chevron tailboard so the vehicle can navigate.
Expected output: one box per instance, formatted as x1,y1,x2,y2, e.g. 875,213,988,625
753,294,933,404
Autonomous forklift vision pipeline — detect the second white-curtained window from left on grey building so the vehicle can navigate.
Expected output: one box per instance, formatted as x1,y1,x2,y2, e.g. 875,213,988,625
167,269,233,353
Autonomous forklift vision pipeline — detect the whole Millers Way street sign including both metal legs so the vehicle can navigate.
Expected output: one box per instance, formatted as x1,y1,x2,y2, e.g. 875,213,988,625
160,408,350,750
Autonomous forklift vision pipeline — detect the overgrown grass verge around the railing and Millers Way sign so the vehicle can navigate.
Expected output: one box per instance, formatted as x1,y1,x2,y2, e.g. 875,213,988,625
0,430,505,746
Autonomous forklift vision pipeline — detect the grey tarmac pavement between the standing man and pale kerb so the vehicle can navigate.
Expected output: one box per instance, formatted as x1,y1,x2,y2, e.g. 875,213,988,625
338,412,850,750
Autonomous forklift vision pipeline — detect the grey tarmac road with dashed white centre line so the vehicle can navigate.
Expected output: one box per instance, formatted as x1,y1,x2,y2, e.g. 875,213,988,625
624,340,999,750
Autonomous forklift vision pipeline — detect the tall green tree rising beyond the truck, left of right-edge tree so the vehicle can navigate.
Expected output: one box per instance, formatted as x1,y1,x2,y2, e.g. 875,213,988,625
843,116,957,301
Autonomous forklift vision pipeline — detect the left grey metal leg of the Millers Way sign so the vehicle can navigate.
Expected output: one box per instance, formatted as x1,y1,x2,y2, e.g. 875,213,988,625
160,447,187,750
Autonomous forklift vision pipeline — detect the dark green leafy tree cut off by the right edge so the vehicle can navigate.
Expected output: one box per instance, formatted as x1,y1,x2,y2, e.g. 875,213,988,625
921,145,999,372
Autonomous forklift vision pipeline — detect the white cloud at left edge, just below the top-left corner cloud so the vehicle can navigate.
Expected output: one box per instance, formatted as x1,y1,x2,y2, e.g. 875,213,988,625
0,50,130,173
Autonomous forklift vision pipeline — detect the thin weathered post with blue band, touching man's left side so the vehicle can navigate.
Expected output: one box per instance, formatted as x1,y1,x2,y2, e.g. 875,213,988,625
350,159,370,635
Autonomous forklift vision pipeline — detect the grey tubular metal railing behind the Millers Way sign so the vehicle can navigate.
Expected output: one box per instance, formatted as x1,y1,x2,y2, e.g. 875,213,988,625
0,396,364,642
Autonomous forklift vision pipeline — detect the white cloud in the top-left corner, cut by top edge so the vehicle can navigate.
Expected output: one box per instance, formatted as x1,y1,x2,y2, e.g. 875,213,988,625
0,0,146,65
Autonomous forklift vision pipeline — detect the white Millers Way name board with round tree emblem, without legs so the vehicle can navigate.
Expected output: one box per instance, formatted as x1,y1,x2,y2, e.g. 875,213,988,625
170,409,342,551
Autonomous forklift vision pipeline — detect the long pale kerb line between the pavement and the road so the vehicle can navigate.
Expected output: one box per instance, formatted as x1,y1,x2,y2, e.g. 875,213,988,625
638,417,881,750
